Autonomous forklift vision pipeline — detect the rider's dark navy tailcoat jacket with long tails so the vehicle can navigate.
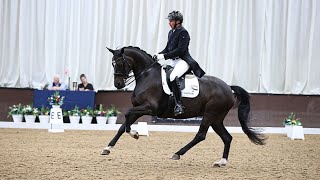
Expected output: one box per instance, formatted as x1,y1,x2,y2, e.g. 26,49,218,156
159,27,205,78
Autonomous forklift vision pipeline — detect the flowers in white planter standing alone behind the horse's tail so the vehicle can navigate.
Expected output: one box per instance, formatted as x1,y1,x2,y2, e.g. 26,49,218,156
283,112,303,139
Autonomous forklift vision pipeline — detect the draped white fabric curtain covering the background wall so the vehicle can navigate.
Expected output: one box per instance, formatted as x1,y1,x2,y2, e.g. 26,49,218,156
0,0,320,94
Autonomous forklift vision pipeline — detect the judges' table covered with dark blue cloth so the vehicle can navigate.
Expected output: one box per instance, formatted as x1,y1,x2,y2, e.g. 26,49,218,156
33,90,96,110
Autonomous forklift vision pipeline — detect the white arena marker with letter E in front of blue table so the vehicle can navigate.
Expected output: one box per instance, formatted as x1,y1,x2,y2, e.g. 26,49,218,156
48,107,64,132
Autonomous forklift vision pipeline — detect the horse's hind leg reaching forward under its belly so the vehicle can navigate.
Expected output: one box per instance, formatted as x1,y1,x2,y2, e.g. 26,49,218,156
172,117,210,160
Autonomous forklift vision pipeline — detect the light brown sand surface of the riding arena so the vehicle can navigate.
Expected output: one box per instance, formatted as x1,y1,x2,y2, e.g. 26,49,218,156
0,129,320,179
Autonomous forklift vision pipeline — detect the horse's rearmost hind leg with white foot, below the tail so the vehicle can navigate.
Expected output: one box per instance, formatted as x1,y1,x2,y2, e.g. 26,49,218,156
211,116,232,167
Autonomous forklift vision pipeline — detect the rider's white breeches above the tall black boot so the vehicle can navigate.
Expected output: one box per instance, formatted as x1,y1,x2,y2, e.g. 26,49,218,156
169,59,190,82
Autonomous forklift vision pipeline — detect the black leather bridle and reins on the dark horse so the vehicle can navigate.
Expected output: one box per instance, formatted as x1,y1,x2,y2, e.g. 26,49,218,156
112,54,158,86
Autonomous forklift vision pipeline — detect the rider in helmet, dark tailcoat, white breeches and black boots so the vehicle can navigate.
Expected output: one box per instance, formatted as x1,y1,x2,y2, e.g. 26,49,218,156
156,11,205,115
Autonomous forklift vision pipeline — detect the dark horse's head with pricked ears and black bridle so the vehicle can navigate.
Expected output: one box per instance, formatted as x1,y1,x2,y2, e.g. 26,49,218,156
107,48,132,89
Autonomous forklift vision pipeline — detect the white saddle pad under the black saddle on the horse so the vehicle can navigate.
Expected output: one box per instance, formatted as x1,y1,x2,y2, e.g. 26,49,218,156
161,68,199,98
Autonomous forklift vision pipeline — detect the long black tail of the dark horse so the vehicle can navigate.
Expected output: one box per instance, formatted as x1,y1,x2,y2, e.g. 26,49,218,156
230,86,266,145
